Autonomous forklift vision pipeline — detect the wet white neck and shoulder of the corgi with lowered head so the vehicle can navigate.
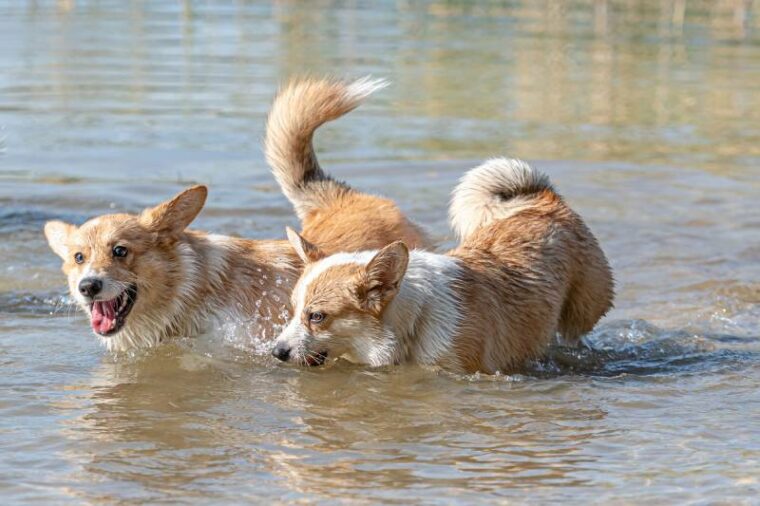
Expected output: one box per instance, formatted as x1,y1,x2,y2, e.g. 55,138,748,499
358,251,463,365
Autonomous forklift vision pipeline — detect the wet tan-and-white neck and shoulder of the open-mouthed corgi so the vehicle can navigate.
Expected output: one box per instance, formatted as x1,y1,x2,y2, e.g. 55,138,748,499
105,232,301,351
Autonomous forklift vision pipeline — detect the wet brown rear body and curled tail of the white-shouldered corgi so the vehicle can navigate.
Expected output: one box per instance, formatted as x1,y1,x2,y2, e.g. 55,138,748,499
450,159,613,370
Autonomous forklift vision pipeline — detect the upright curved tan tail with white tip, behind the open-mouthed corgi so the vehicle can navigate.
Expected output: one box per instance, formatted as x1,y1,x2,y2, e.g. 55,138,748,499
265,77,387,219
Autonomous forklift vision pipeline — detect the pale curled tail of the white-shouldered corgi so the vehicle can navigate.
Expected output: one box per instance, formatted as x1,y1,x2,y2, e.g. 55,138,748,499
449,158,554,241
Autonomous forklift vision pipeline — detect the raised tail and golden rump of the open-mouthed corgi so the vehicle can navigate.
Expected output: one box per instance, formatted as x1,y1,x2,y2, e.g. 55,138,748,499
265,78,428,251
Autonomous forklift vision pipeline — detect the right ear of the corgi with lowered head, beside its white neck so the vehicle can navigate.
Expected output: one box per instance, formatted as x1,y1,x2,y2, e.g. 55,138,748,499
358,241,409,314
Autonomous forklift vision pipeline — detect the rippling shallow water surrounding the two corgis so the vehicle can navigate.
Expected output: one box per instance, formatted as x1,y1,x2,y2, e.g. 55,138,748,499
0,0,760,503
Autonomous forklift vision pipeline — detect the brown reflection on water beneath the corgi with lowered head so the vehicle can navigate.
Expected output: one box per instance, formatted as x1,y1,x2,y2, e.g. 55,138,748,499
270,370,605,496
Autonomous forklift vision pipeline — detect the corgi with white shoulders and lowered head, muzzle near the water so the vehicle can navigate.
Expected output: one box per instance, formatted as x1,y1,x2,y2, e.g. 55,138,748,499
272,159,613,373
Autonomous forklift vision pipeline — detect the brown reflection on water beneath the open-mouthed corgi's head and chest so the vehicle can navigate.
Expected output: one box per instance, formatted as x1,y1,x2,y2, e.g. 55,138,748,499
57,345,258,500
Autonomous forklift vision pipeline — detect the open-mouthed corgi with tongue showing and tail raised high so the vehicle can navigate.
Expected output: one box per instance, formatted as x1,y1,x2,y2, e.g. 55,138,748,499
45,78,429,351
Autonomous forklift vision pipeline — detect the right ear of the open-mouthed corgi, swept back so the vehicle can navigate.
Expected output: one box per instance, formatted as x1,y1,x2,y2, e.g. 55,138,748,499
140,185,208,234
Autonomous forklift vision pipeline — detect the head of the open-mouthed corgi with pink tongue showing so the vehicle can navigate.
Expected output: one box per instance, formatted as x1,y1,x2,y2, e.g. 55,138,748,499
45,186,207,346
